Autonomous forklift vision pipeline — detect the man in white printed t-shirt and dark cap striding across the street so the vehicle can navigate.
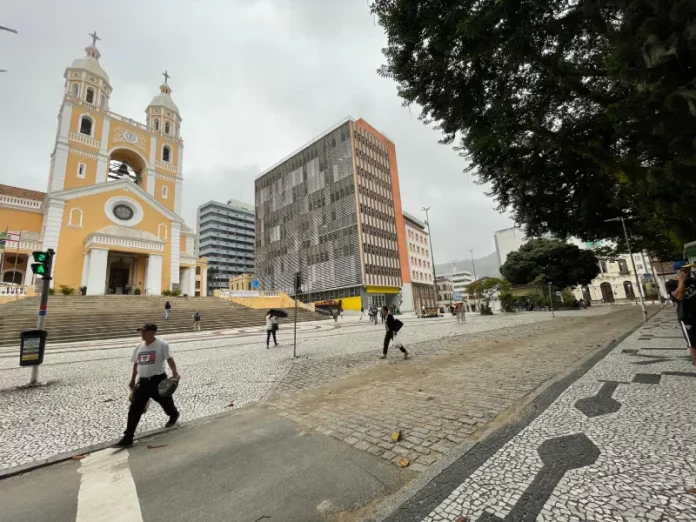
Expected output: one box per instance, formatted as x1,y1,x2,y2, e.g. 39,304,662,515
116,323,180,447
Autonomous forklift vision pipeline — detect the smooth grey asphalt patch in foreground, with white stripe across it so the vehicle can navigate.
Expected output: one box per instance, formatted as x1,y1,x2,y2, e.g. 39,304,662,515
0,409,413,522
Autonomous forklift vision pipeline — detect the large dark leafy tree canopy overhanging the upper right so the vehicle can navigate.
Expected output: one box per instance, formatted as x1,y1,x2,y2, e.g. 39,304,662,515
371,0,696,255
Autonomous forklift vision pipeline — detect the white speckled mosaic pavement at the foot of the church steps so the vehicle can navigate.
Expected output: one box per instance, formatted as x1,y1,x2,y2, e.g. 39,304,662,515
0,307,612,471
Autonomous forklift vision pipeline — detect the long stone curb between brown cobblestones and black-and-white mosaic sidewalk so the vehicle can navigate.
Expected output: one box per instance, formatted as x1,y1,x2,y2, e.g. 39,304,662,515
361,310,662,522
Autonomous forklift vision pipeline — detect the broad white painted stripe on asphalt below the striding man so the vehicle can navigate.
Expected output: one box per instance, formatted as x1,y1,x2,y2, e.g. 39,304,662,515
75,448,143,522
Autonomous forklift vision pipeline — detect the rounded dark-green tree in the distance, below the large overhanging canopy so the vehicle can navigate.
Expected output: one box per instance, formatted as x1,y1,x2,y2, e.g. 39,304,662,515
500,238,600,288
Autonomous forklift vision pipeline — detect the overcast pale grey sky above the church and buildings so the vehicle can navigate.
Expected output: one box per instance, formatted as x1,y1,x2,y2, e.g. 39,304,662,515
0,0,512,263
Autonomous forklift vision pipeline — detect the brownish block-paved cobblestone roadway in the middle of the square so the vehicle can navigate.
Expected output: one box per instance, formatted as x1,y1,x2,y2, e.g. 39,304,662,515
267,307,641,472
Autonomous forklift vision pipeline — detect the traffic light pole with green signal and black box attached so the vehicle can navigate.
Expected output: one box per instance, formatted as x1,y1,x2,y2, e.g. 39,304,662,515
24,248,55,384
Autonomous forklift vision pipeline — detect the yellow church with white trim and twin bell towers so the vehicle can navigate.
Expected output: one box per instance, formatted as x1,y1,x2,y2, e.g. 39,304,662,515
0,33,207,296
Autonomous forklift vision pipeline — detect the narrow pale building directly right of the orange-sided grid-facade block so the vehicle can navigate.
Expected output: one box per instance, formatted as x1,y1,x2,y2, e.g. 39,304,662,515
401,212,436,313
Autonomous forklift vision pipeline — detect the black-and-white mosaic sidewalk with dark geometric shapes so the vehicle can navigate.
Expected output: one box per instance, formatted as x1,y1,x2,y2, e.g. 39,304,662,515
387,308,696,522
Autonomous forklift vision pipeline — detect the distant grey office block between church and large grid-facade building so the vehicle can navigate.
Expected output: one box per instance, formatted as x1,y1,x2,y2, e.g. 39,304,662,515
197,199,255,294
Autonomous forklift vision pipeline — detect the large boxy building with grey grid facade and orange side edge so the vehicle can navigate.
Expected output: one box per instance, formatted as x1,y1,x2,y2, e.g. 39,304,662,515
255,118,410,310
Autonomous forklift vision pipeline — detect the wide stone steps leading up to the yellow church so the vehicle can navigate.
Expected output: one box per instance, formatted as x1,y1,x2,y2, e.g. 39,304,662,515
0,295,326,346
